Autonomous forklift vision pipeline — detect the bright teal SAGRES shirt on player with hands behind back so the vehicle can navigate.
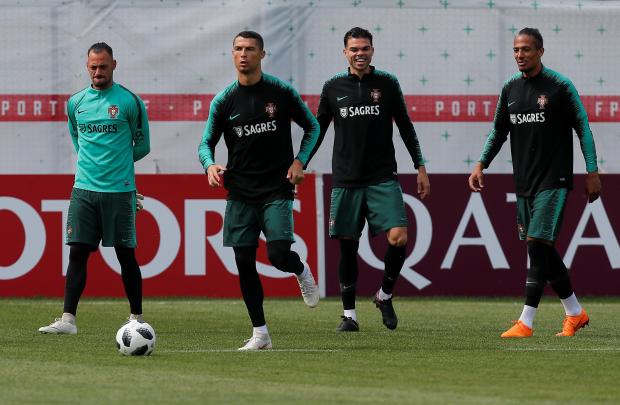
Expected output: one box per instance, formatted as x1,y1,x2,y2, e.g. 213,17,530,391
67,83,150,193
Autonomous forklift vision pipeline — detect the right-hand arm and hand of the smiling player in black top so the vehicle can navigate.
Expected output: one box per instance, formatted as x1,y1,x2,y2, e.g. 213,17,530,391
393,78,431,199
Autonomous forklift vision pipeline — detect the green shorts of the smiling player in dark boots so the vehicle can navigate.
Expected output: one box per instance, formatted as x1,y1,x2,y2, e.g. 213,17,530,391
329,180,408,239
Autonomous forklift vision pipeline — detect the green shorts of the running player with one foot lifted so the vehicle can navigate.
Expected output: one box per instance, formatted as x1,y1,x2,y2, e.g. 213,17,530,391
224,200,295,247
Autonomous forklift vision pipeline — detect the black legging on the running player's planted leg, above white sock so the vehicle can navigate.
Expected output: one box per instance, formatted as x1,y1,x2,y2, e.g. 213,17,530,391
233,246,265,328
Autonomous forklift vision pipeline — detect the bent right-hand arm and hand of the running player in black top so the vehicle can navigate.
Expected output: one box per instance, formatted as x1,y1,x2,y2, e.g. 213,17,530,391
286,88,319,184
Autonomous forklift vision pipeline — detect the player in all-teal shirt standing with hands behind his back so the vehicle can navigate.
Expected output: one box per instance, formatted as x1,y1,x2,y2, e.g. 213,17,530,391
39,42,150,335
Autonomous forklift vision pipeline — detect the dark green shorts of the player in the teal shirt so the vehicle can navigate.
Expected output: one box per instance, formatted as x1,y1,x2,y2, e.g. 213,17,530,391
66,188,137,249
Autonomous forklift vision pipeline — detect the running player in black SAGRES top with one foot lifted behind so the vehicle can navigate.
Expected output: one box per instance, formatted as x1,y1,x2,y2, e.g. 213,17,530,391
198,31,319,350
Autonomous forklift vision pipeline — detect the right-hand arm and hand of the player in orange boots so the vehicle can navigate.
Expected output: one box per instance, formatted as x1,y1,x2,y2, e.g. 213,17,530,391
566,81,602,202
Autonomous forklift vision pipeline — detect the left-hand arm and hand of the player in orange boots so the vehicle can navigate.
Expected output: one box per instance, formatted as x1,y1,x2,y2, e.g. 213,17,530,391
468,84,510,192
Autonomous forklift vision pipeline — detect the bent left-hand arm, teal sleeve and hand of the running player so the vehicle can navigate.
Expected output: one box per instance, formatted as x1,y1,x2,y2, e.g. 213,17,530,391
198,96,226,187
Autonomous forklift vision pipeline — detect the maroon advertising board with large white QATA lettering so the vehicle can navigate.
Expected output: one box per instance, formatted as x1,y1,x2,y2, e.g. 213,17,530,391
323,174,620,296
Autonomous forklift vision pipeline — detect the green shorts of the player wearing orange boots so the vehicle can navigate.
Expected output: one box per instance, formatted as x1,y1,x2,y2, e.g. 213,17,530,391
517,188,568,241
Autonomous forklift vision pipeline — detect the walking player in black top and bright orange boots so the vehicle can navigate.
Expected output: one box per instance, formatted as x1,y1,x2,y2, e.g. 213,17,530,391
469,28,601,338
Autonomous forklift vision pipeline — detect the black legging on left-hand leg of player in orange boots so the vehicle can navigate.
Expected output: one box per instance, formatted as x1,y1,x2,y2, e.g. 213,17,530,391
525,241,552,308
